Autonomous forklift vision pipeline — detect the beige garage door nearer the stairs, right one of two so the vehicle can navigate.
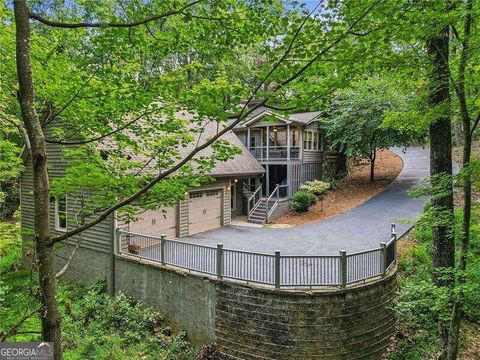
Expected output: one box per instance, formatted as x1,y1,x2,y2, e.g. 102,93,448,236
188,189,222,234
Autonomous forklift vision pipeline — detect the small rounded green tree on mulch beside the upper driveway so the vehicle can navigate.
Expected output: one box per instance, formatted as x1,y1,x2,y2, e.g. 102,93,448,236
319,77,412,181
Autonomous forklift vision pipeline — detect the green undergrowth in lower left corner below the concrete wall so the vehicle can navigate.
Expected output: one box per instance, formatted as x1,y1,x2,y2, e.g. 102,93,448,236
0,223,198,360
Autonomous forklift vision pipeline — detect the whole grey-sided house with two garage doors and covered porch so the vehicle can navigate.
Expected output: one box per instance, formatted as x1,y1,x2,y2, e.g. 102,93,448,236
21,107,335,248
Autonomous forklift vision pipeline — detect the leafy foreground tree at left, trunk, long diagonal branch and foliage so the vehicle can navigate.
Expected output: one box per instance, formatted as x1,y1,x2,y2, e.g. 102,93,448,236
10,0,386,358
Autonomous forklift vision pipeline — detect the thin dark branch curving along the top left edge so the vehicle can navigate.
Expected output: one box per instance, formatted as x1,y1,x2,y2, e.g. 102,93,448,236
29,0,204,29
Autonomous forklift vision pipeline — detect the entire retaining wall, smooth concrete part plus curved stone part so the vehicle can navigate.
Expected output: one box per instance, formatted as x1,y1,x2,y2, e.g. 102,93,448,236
51,249,397,360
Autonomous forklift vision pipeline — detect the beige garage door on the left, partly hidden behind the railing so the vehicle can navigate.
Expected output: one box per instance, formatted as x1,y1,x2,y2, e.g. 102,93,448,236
129,207,177,238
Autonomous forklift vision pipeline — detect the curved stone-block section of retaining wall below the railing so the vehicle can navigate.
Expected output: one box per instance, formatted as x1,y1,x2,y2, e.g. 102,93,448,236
215,274,397,360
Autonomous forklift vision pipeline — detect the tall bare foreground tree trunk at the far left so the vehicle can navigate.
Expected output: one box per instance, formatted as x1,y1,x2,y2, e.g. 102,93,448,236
13,0,62,359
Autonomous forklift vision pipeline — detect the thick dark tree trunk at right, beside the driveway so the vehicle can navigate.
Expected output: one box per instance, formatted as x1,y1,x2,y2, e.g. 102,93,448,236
427,26,455,358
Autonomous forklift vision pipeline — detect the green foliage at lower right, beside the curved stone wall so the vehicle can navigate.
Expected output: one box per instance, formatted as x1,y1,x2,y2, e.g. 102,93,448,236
390,209,480,359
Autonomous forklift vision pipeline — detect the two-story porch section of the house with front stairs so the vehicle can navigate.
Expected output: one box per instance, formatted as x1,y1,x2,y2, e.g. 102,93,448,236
230,107,335,223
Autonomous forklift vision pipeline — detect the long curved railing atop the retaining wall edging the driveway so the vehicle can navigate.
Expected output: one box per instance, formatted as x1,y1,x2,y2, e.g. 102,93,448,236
117,224,397,288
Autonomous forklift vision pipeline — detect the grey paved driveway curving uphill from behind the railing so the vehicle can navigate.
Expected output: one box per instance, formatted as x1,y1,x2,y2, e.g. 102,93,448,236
181,147,429,255
